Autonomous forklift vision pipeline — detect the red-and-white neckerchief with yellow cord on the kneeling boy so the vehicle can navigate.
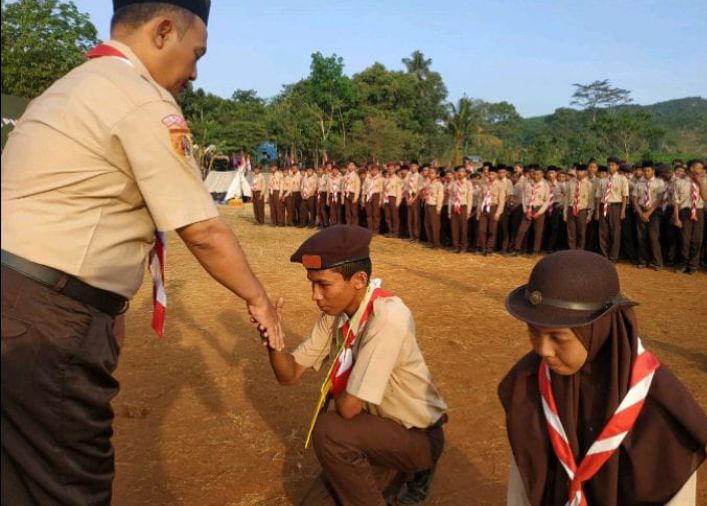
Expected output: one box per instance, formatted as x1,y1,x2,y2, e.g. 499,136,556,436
304,279,393,449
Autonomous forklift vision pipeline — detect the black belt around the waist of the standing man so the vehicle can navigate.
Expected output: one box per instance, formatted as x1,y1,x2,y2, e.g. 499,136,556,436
2,250,128,316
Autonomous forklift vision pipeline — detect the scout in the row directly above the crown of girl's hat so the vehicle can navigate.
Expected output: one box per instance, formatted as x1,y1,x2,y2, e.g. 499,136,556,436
562,165,595,249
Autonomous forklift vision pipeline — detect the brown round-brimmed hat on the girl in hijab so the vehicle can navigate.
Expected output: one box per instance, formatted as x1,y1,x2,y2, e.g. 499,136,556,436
506,250,635,328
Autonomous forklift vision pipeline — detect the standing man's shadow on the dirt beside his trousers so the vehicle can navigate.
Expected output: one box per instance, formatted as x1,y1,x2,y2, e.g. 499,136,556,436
114,280,225,505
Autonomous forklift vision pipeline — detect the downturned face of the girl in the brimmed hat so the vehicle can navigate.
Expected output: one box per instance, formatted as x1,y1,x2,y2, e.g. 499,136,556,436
528,325,587,376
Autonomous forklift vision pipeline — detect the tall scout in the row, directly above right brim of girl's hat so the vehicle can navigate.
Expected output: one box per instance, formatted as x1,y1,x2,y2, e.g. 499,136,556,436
595,157,629,262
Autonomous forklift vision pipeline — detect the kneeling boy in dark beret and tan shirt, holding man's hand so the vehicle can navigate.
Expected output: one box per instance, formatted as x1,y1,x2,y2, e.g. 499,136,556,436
260,225,447,506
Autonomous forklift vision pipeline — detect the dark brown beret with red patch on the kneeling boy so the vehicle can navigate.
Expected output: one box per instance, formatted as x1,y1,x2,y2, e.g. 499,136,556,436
290,225,373,270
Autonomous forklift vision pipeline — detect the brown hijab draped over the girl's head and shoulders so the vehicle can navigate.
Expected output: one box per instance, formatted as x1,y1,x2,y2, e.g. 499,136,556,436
498,305,707,506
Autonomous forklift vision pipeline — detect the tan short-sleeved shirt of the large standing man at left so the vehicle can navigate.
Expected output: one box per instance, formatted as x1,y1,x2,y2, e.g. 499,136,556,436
0,41,218,298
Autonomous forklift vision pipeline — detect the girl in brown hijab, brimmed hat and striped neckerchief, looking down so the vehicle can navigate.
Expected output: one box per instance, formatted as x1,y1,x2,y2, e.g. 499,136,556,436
498,250,707,506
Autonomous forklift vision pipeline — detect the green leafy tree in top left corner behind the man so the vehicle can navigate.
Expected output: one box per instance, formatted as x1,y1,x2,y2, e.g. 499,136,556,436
2,0,98,98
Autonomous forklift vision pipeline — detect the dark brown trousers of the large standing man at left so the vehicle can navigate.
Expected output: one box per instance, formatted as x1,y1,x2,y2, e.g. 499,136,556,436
0,266,119,506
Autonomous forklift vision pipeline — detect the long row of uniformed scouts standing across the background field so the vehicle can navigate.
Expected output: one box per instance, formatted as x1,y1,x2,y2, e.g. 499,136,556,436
253,157,707,274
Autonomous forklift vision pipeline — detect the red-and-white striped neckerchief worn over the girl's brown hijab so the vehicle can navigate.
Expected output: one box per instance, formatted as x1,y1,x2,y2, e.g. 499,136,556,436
538,338,660,506
